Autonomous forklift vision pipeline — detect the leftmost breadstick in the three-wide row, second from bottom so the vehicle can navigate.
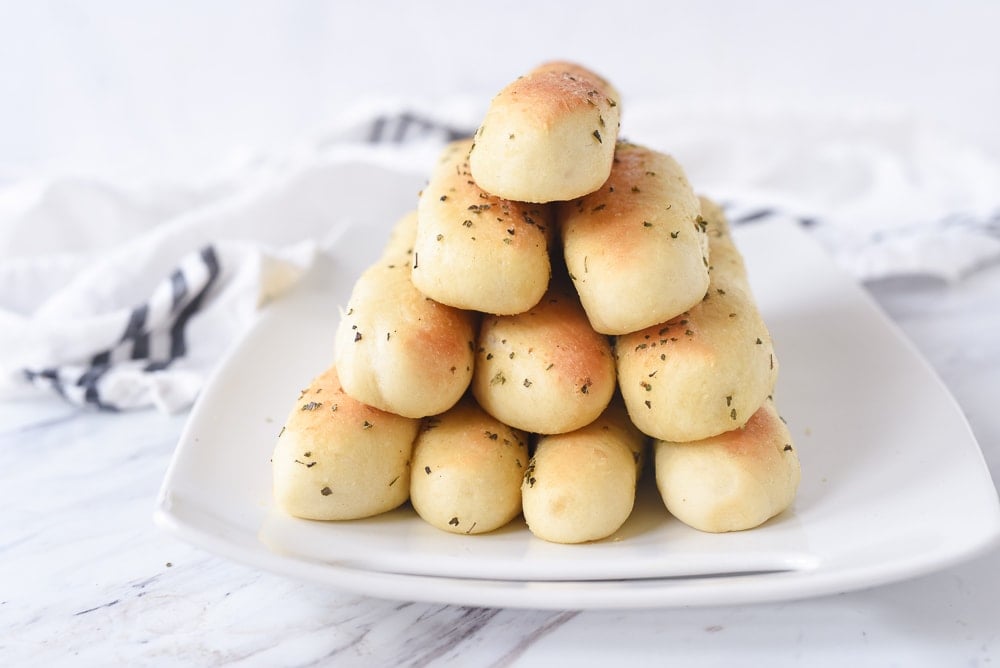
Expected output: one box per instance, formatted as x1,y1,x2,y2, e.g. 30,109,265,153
334,214,478,418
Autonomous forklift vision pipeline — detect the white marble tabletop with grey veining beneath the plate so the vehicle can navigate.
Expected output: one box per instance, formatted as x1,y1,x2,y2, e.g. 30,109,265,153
0,258,1000,667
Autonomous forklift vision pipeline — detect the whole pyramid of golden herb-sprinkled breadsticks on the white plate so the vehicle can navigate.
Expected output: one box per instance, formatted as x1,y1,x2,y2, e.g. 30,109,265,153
272,62,800,543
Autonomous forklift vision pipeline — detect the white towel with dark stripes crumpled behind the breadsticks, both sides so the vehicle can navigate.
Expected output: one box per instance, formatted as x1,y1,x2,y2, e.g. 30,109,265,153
0,104,1000,412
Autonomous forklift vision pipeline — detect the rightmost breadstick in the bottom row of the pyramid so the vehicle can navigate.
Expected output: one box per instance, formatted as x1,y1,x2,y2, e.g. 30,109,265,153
653,400,801,532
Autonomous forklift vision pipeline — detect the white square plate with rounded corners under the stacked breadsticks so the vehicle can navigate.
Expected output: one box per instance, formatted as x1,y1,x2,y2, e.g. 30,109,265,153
155,165,1000,609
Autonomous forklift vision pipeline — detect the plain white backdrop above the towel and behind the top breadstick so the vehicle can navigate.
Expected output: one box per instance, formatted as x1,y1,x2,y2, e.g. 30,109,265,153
0,0,1000,184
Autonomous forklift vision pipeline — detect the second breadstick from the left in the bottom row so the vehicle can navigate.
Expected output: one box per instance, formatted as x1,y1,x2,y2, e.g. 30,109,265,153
410,397,528,534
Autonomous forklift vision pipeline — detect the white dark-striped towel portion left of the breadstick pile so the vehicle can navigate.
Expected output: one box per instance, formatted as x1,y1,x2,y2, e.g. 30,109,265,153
0,106,469,413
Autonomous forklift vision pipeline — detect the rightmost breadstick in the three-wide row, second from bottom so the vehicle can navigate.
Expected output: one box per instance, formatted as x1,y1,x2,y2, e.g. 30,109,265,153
615,200,778,441
